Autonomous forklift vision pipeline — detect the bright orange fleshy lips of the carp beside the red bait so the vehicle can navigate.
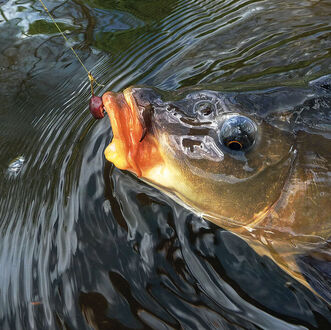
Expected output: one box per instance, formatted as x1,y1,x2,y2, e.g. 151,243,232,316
102,89,163,177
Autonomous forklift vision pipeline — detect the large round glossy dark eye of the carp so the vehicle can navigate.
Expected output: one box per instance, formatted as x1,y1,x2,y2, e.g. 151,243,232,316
220,116,257,151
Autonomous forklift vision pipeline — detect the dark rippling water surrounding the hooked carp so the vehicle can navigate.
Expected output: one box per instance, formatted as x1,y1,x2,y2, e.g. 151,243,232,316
0,0,331,329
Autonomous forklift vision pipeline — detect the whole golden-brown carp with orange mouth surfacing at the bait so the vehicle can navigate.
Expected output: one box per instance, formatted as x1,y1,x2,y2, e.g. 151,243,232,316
103,76,331,300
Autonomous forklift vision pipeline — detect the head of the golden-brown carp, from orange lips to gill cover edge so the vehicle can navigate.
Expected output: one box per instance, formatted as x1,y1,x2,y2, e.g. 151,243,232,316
103,87,296,228
